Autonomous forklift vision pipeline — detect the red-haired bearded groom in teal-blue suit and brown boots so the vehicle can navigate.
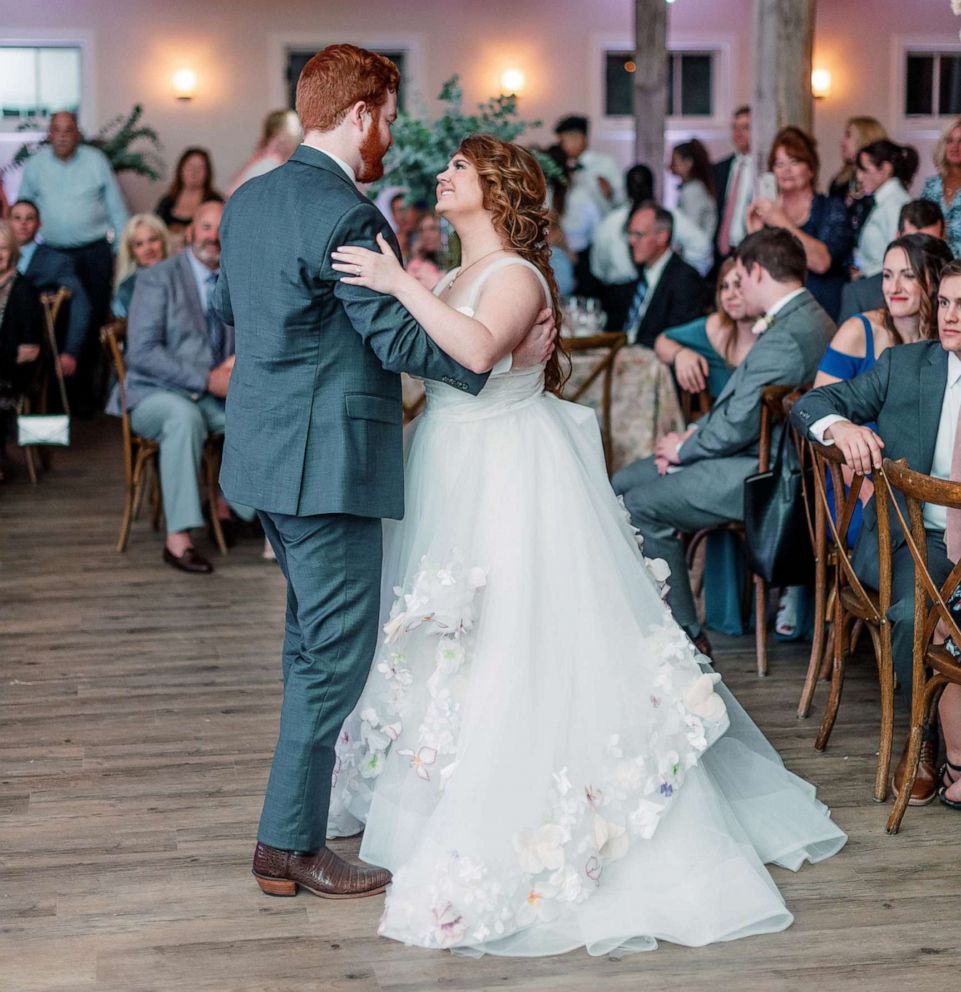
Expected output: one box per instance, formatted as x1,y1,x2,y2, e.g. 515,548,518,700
214,45,554,898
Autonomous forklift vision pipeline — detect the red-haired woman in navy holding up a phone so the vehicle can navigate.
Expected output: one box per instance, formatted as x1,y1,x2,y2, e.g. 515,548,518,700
747,127,852,320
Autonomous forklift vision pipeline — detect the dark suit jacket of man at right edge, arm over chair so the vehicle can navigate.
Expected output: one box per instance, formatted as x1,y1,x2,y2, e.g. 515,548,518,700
791,341,948,585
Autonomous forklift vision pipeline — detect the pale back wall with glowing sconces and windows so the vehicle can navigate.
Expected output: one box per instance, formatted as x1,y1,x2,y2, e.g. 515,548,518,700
0,0,961,208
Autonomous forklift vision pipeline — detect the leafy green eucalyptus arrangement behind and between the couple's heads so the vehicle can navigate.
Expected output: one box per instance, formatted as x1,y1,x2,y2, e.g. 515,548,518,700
371,76,558,203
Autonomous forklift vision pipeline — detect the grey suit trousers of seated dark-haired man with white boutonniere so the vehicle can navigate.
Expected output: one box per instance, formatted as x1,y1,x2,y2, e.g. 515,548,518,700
612,457,731,637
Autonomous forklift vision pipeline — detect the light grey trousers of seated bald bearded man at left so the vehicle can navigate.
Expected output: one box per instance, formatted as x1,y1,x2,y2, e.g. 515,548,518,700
130,389,254,534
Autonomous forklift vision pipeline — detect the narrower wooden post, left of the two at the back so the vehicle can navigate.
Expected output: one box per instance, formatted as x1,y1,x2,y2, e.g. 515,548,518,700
634,0,668,199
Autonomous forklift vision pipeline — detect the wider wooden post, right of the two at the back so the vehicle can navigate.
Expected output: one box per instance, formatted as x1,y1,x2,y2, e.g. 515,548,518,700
751,0,816,175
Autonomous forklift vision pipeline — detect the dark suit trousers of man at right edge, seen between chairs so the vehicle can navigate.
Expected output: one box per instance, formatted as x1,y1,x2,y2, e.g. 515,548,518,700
854,521,952,708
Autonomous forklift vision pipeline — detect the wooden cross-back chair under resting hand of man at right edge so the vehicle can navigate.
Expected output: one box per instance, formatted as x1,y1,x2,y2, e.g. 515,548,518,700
802,441,896,802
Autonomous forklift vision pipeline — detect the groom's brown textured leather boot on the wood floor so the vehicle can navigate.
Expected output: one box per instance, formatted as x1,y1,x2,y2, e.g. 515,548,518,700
252,842,390,899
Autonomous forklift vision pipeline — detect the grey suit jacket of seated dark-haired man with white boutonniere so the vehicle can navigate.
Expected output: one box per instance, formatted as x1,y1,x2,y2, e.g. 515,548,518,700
680,289,835,520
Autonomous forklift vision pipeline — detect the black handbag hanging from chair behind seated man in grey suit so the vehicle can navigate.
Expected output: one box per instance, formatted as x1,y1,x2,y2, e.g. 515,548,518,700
744,425,814,586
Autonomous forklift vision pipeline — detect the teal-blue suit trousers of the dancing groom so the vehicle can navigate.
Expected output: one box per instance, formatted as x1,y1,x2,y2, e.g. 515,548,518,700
257,511,382,851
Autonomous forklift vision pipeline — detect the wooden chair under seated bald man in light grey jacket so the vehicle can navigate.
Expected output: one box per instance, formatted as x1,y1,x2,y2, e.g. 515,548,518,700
100,319,227,555
